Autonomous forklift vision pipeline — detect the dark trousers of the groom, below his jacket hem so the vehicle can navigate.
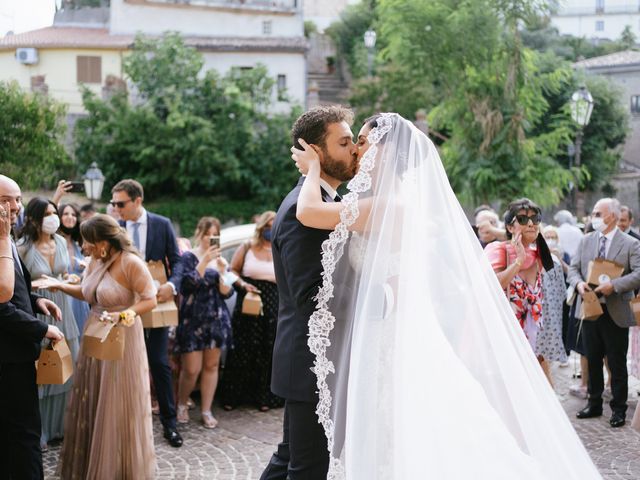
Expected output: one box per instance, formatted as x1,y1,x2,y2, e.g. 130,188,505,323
260,400,329,480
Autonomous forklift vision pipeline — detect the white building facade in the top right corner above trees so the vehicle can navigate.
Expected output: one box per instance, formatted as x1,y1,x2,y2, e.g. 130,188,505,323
551,0,640,40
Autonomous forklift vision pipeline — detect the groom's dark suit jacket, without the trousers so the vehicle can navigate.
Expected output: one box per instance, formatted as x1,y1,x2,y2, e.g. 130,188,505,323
271,178,333,402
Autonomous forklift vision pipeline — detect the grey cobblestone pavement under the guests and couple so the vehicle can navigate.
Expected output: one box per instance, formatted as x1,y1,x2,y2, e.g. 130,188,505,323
44,359,640,480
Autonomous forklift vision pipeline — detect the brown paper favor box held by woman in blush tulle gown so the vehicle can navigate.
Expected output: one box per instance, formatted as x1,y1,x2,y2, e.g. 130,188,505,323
82,315,127,360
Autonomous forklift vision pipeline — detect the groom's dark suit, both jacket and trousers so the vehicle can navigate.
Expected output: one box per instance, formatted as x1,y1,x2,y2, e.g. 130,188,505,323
261,178,334,480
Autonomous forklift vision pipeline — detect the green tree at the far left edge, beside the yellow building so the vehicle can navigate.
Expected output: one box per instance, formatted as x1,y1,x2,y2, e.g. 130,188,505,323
0,82,72,189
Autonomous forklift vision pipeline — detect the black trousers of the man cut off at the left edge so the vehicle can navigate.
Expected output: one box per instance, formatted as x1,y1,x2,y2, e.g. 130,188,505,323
0,362,44,480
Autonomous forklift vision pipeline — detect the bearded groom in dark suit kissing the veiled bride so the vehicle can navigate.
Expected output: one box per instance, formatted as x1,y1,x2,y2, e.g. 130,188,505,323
260,106,358,480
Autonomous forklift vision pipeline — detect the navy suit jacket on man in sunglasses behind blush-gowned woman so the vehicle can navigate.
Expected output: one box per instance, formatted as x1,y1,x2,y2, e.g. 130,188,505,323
120,214,180,292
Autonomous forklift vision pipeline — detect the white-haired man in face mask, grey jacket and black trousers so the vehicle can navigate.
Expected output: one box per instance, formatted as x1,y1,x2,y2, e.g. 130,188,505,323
568,198,640,427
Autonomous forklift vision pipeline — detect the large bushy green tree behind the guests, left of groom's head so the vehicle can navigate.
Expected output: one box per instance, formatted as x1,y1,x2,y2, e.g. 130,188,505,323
76,34,297,203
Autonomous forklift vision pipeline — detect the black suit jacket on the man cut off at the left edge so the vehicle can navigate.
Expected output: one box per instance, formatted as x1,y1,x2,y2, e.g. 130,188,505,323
0,248,49,363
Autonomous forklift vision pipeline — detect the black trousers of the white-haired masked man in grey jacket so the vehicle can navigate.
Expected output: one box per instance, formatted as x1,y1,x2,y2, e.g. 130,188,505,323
582,305,629,414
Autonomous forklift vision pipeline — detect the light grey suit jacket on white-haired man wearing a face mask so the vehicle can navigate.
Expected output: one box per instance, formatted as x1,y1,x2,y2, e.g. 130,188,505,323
567,230,640,327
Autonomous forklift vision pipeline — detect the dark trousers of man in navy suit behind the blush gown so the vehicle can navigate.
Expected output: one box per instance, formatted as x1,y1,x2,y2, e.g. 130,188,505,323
144,327,176,429
